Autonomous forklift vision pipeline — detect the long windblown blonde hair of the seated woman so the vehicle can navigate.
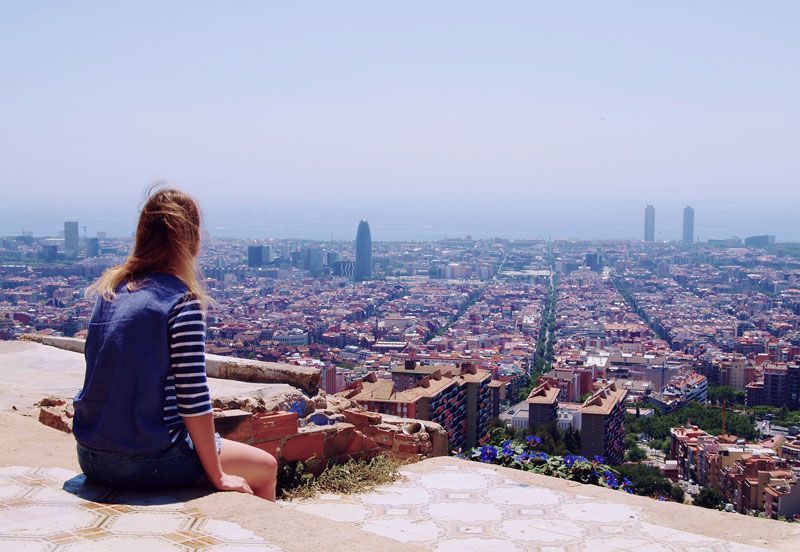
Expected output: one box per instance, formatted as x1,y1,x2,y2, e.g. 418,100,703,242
86,185,208,308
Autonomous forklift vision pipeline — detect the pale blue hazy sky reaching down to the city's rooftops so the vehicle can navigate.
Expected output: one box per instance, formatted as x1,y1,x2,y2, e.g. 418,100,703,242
0,0,800,239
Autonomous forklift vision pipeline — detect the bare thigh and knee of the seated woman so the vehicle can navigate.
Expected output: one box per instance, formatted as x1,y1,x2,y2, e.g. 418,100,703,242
219,439,278,502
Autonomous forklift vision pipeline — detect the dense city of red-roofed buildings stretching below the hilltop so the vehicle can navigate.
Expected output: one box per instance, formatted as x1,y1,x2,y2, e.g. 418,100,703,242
0,205,800,519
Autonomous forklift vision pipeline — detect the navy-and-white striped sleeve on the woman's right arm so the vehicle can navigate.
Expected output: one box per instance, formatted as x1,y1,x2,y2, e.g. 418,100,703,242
167,298,212,417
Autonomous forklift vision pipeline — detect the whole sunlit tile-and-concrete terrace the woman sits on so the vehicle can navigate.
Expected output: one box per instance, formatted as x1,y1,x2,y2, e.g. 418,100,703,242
0,342,800,552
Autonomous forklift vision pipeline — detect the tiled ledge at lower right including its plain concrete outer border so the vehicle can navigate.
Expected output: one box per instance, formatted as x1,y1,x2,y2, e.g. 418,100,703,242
286,457,800,552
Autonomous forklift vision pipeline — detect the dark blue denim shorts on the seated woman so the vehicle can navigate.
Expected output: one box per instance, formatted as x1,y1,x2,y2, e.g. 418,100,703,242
78,433,221,491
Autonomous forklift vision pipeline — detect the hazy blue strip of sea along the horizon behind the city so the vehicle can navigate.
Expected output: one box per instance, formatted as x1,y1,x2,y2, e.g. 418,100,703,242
0,198,800,242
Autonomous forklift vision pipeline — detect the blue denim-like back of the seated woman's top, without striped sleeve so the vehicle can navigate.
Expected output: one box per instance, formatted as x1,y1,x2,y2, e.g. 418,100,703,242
73,273,187,453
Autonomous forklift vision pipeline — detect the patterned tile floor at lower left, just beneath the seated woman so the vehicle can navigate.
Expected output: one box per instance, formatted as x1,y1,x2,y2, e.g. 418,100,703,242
0,467,280,552
